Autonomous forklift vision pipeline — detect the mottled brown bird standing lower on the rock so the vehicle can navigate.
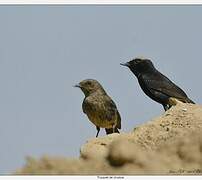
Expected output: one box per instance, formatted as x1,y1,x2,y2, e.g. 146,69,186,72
75,79,121,137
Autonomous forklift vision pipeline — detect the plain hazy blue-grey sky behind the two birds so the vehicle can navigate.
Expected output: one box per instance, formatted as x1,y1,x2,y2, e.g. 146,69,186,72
0,5,202,174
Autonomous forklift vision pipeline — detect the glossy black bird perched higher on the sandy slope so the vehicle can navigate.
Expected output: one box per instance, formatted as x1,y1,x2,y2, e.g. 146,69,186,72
120,58,195,111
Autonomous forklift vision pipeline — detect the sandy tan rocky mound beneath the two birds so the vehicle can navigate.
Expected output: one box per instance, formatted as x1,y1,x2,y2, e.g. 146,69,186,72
16,102,202,175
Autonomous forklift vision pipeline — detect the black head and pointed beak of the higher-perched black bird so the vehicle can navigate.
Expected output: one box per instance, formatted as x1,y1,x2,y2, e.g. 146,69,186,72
121,58,154,77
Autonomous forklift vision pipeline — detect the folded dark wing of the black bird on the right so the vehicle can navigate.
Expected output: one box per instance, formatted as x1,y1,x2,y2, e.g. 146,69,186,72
144,76,187,99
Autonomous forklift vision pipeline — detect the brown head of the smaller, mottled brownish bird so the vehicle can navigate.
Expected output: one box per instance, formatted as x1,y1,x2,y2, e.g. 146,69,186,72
74,79,105,96
